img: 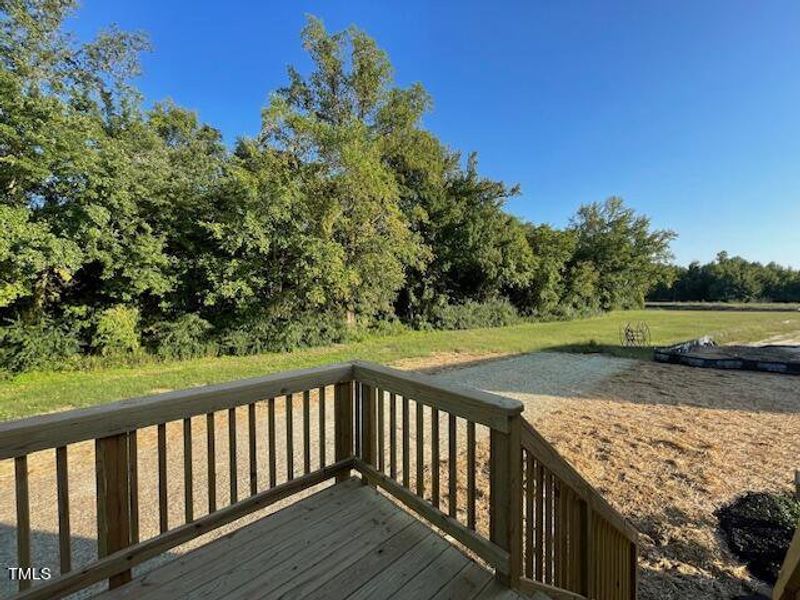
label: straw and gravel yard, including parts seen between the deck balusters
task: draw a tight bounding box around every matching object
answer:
[0,352,800,600]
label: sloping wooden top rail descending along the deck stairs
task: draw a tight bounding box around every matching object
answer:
[520,419,639,546]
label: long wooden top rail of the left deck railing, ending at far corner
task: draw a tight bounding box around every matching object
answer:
[0,363,353,460]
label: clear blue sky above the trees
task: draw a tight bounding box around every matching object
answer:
[68,0,800,267]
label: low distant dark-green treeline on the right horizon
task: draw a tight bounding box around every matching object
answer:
[648,252,800,302]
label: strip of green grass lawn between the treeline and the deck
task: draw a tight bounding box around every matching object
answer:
[0,310,800,420]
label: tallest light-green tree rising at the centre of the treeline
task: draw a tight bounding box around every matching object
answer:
[260,18,424,320]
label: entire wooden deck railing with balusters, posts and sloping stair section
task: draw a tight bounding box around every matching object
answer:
[0,361,636,600]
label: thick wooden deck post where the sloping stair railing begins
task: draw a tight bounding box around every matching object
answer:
[489,414,522,589]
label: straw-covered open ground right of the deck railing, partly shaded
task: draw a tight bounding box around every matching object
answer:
[440,353,800,600]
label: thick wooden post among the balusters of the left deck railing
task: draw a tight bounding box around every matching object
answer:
[95,433,132,589]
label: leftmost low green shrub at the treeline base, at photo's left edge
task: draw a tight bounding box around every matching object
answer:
[0,318,81,373]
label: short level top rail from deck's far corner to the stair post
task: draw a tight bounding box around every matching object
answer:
[353,360,525,433]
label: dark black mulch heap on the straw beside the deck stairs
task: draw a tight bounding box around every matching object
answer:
[716,492,800,585]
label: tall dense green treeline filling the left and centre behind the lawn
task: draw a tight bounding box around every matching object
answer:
[0,0,674,371]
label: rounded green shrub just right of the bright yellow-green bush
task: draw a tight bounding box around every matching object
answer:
[148,314,217,360]
